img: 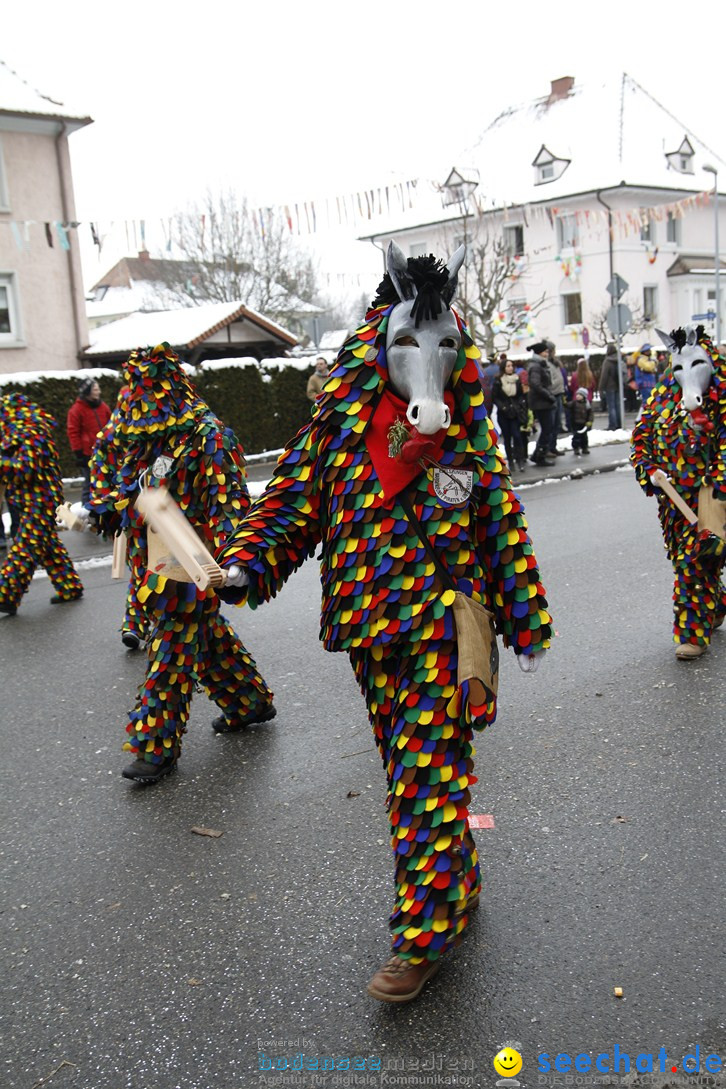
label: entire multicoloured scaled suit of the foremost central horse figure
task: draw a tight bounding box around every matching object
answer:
[219,305,551,963]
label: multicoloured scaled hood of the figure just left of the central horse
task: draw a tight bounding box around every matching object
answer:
[114,343,207,441]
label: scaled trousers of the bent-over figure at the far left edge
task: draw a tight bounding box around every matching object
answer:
[0,491,83,608]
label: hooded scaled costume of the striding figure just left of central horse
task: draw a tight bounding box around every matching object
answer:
[89,344,272,763]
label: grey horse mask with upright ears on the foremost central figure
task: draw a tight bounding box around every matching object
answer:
[385,242,466,435]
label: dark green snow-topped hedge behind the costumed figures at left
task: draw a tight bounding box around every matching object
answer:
[0,359,315,477]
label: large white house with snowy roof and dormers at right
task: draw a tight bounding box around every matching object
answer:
[366,74,726,355]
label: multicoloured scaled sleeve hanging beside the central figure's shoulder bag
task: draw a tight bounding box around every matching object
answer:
[477,425,552,654]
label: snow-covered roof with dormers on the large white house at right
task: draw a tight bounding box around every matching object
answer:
[366,73,726,237]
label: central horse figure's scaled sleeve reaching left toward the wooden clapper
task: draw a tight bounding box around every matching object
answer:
[217,426,322,609]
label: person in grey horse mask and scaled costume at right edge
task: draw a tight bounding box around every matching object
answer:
[630,326,726,661]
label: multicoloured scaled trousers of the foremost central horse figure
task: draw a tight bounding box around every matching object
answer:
[349,612,484,964]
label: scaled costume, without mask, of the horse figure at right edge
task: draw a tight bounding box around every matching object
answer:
[630,337,726,646]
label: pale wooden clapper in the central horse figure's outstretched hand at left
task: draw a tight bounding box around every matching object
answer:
[136,485,225,590]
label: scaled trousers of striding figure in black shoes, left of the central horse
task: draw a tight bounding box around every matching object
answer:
[124,574,272,763]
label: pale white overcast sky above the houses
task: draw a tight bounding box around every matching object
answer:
[0,0,726,289]
